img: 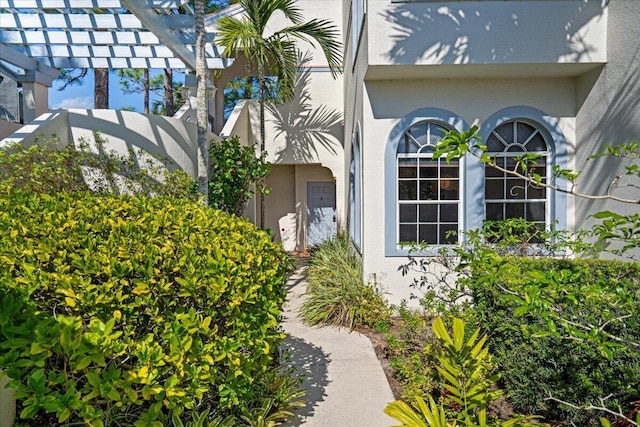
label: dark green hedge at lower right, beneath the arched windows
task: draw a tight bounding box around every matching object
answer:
[466,257,640,426]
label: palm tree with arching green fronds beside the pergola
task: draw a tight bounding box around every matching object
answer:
[218,0,342,227]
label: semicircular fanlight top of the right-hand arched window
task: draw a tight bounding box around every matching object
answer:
[487,120,549,154]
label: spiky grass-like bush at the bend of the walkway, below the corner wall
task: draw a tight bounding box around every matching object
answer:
[300,235,391,329]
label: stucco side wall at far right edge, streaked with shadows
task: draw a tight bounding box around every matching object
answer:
[576,0,640,249]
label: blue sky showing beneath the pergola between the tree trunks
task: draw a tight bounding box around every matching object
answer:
[49,70,184,113]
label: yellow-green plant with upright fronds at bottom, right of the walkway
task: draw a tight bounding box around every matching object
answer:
[385,317,546,427]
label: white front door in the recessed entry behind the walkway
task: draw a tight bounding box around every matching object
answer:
[307,182,336,246]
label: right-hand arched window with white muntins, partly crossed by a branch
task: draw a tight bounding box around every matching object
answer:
[484,119,551,228]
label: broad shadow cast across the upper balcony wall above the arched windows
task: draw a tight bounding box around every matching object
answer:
[380,1,603,64]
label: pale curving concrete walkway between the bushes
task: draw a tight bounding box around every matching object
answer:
[281,267,397,427]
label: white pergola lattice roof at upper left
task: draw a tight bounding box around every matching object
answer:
[0,0,239,70]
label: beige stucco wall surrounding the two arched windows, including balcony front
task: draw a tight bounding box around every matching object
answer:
[343,0,640,303]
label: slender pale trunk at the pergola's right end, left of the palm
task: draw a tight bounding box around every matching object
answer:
[195,0,209,206]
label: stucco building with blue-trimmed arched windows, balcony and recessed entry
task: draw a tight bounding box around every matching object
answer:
[219,0,640,303]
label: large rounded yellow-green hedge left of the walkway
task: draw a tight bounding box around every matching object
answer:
[0,192,287,426]
